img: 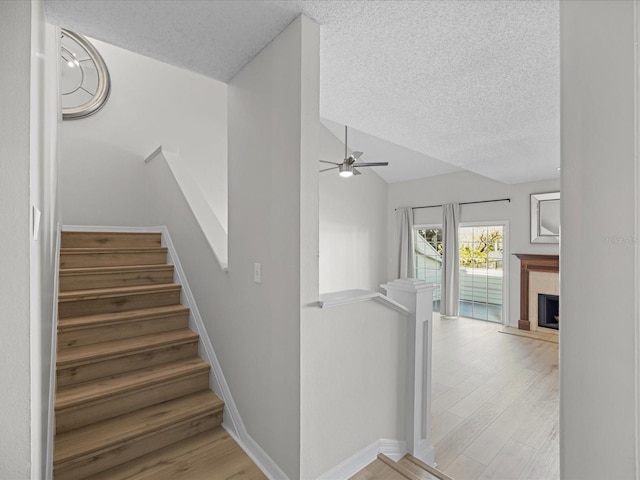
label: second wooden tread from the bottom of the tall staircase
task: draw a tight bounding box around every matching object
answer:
[55,357,210,411]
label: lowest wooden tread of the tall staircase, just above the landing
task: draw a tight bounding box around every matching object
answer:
[53,390,224,466]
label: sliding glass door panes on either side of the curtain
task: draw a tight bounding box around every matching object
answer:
[415,224,506,323]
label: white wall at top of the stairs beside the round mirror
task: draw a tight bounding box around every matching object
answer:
[60,40,227,229]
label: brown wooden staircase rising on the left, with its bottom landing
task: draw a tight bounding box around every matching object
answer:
[53,232,266,480]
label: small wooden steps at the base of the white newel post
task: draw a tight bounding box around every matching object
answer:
[350,453,452,480]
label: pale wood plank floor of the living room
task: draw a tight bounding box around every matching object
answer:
[432,314,560,480]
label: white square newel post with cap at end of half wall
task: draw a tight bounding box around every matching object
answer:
[381,278,436,465]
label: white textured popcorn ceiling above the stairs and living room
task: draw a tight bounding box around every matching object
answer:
[45,0,560,183]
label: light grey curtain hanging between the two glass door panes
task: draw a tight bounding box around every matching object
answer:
[440,203,460,317]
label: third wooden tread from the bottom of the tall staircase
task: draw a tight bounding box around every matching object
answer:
[56,328,199,368]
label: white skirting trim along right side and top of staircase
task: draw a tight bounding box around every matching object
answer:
[60,225,288,480]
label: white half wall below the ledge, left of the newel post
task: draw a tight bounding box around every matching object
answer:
[300,301,407,480]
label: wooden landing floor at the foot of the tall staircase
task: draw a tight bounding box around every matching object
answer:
[91,426,267,480]
